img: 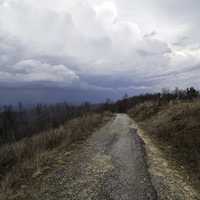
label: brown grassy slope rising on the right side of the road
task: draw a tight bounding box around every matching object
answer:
[129,100,200,190]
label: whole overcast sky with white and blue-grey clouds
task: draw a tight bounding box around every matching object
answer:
[0,0,200,103]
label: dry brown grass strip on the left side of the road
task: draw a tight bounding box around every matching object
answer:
[0,113,111,199]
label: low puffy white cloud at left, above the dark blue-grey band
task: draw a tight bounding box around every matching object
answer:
[0,60,79,86]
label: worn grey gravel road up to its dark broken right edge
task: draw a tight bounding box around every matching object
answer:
[29,114,157,200]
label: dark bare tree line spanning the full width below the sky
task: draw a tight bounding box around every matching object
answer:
[0,87,199,146]
